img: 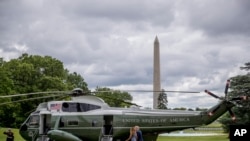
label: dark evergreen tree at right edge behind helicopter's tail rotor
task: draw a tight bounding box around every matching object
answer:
[219,63,250,132]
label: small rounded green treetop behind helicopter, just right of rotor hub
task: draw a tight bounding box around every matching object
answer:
[95,87,132,107]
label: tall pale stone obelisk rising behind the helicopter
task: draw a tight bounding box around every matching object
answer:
[153,36,161,109]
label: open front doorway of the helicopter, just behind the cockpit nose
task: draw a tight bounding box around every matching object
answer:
[39,111,51,135]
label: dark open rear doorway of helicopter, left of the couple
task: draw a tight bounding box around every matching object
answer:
[103,115,113,135]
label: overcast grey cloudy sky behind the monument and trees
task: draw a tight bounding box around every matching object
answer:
[0,0,250,108]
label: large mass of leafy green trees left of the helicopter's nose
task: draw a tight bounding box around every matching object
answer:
[0,54,88,127]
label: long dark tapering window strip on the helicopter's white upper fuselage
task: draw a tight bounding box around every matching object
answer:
[62,102,101,112]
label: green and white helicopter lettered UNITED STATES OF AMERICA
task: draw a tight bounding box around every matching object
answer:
[0,80,248,141]
